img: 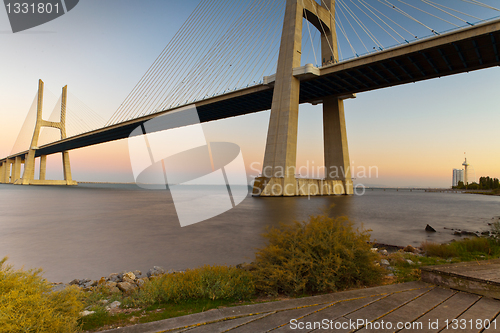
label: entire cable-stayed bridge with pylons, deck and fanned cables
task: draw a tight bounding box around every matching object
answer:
[0,0,500,196]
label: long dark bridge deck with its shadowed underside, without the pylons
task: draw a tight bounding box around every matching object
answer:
[4,20,500,158]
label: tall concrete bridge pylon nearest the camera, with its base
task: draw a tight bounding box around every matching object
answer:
[253,0,353,196]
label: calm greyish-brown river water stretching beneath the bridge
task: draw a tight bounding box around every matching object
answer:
[0,184,500,282]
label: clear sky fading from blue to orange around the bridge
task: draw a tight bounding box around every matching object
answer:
[0,0,500,187]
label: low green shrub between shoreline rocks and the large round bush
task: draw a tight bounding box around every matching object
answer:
[128,266,255,306]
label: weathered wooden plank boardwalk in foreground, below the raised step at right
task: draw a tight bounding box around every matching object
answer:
[99,281,500,333]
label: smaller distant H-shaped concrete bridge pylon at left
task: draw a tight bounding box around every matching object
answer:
[16,80,78,185]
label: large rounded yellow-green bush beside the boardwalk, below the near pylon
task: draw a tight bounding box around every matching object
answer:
[252,215,382,295]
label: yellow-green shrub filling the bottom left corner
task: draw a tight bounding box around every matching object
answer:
[0,258,83,333]
